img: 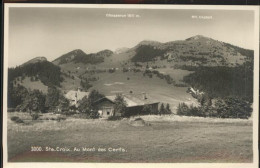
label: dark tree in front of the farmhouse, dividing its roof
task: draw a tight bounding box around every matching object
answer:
[113,94,127,116]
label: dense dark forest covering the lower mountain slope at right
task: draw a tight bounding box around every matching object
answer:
[183,62,253,103]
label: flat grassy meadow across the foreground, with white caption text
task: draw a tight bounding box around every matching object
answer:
[8,112,253,163]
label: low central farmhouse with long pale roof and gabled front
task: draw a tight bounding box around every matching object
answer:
[94,93,159,118]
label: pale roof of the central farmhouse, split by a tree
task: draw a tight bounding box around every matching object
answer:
[97,94,159,107]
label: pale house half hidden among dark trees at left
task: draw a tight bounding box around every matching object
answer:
[65,89,89,107]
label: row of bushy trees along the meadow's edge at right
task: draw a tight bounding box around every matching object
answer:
[177,97,252,118]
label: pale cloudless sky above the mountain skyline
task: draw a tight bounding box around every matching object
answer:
[8,7,254,67]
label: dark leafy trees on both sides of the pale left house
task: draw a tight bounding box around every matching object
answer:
[8,86,104,118]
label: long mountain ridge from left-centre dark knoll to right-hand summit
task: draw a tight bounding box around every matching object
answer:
[49,35,254,69]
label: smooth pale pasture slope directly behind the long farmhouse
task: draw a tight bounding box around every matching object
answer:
[93,72,197,111]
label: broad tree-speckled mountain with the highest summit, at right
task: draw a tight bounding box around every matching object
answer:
[131,35,253,66]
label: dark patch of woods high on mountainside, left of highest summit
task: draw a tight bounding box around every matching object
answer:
[131,45,165,62]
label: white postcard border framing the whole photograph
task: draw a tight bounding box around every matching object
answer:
[3,3,259,168]
